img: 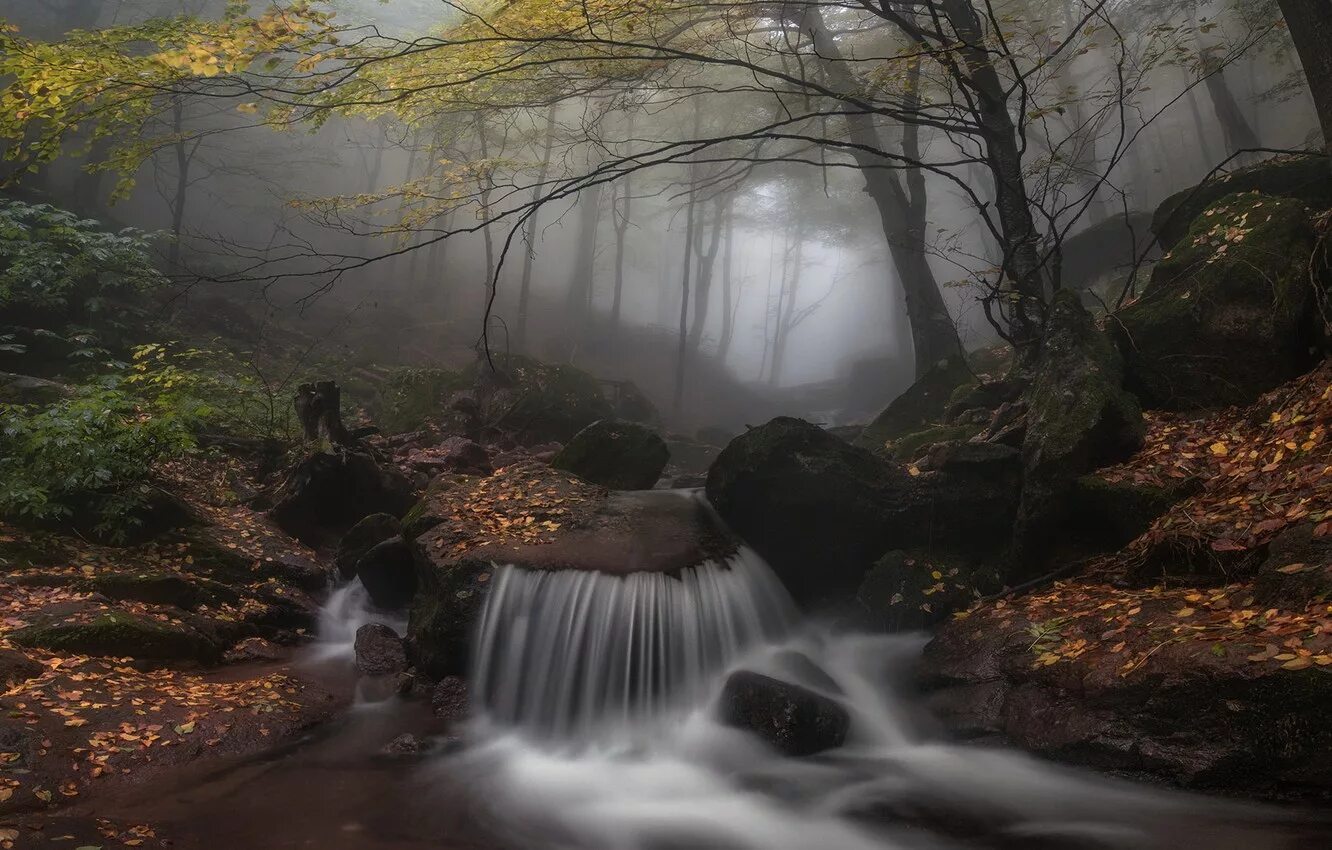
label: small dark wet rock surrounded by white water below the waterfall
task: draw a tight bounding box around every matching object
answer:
[719,670,851,758]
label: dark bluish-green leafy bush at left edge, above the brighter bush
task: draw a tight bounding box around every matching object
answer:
[0,201,164,370]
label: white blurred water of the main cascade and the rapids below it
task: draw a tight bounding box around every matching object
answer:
[437,554,1309,850]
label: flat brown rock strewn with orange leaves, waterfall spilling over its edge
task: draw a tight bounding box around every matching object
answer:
[408,462,738,678]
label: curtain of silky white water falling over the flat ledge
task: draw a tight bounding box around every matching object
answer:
[472,549,795,739]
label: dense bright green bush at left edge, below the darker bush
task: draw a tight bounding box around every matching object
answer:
[0,377,193,540]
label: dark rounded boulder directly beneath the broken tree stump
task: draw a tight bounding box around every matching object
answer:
[269,452,414,545]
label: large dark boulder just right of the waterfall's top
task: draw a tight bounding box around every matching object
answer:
[707,417,907,604]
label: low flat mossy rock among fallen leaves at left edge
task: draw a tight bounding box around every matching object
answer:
[8,612,221,663]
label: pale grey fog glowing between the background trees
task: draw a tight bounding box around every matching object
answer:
[0,0,1320,430]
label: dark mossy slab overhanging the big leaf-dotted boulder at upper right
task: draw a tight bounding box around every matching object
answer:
[1151,156,1332,249]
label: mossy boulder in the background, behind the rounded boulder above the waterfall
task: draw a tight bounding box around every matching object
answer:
[465,354,614,445]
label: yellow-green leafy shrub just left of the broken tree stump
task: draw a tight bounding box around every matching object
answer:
[125,342,296,442]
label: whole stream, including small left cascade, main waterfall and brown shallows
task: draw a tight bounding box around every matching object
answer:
[80,553,1327,850]
